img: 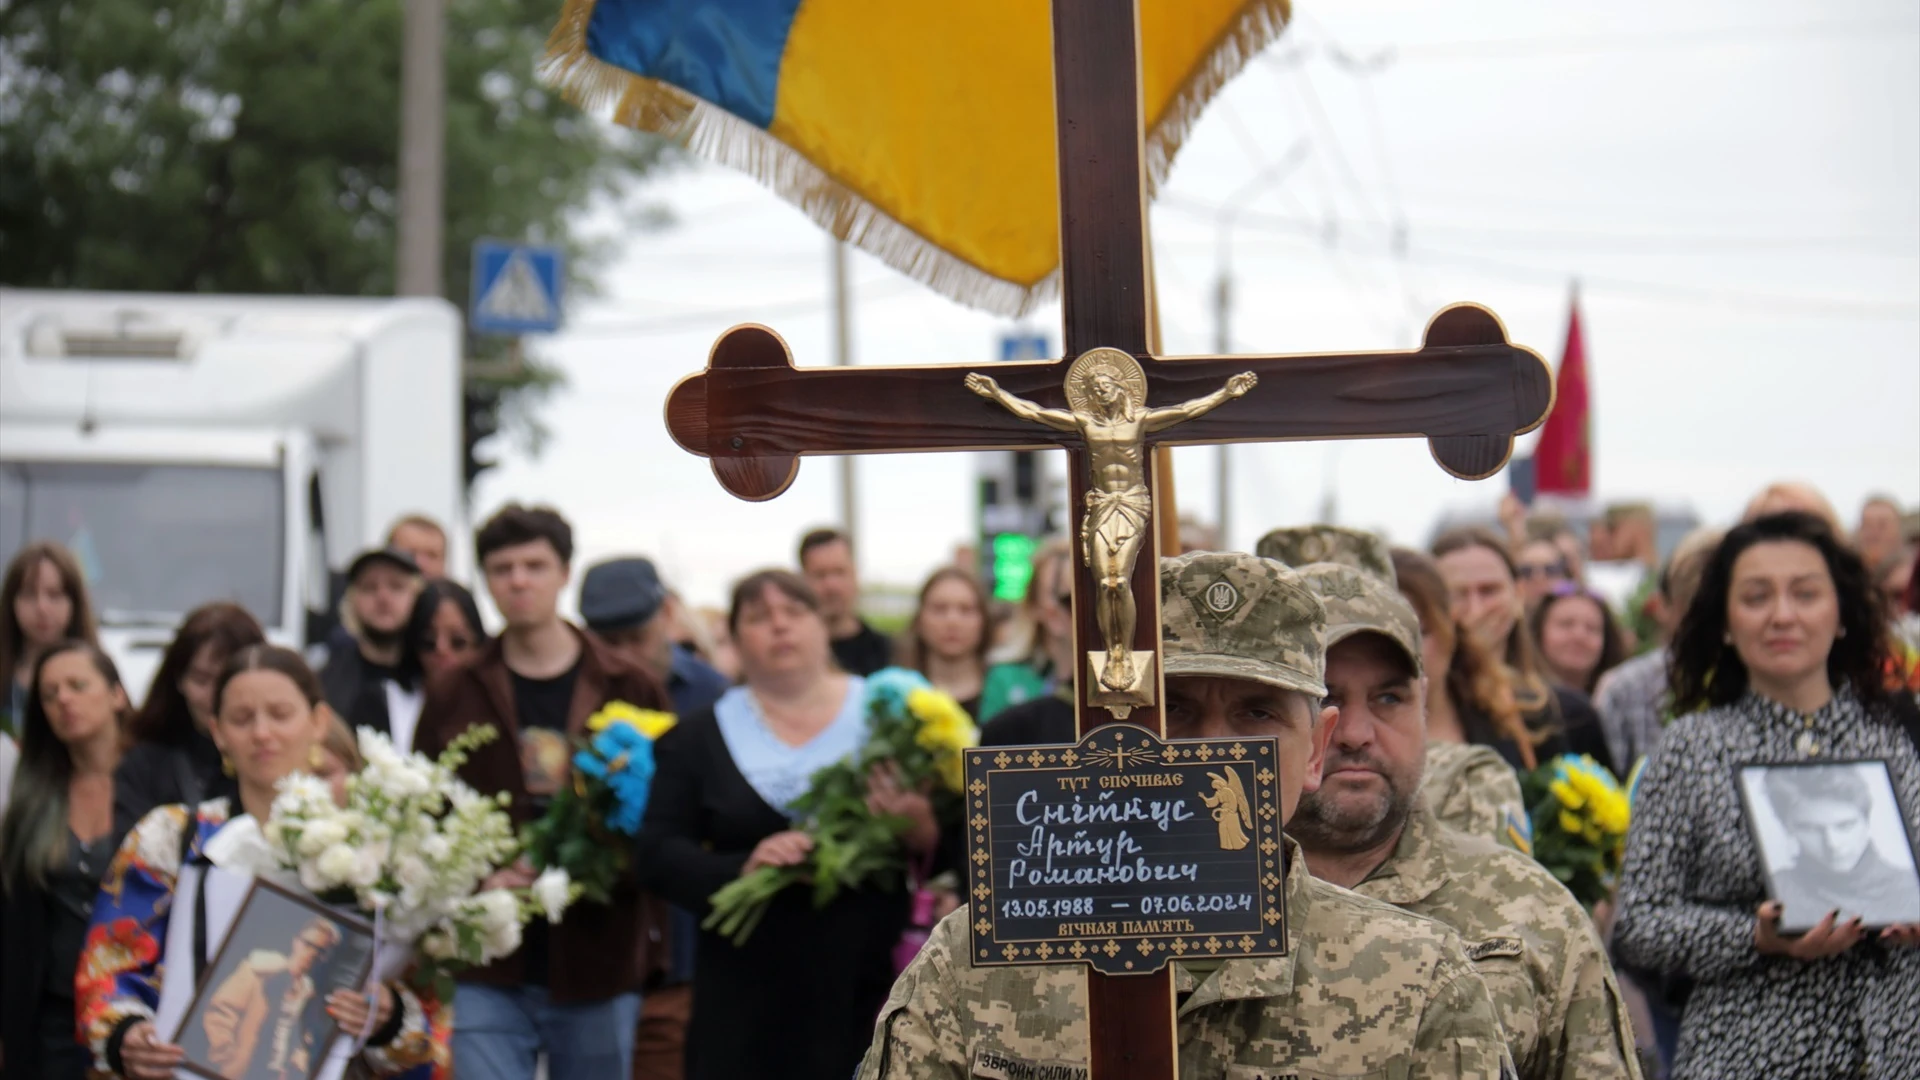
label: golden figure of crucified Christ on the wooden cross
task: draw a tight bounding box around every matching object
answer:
[966,348,1258,717]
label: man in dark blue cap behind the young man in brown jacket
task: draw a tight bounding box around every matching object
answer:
[580,557,728,1080]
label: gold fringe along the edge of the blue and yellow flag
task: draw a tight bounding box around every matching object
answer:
[540,0,1290,317]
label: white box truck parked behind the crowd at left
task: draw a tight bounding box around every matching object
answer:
[0,288,467,700]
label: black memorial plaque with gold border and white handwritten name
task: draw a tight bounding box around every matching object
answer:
[966,724,1286,974]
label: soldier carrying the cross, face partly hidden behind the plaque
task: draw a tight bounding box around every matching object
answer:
[858,552,1513,1080]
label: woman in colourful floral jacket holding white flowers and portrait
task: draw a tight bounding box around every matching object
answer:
[75,646,445,1080]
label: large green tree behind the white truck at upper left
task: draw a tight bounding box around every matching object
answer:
[0,0,664,482]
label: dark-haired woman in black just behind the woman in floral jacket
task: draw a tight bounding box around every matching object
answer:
[113,601,267,834]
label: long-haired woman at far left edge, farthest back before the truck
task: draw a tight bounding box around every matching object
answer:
[0,540,100,732]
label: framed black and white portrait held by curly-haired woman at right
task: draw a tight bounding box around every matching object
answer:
[1740,759,1920,934]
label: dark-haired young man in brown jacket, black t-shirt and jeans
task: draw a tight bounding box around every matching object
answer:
[417,505,672,1080]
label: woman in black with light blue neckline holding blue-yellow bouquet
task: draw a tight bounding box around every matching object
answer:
[637,571,939,1080]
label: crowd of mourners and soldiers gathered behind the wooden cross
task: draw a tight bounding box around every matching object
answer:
[0,484,1920,1080]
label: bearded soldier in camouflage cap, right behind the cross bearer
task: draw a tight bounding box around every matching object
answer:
[1288,563,1640,1080]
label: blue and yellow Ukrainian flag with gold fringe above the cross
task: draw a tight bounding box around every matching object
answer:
[545,0,1288,313]
